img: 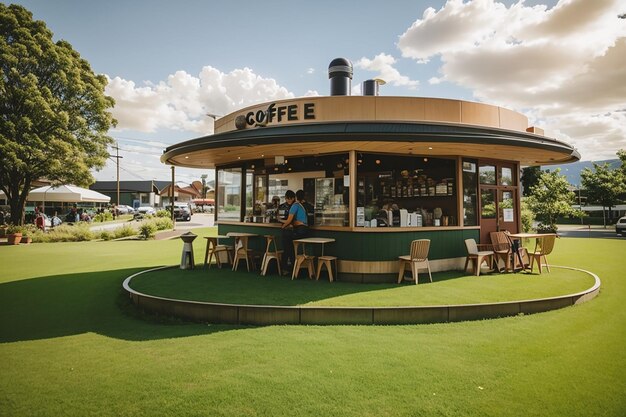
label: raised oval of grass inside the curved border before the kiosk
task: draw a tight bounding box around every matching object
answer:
[131,264,594,307]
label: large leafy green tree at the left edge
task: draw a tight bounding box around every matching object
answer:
[0,3,116,224]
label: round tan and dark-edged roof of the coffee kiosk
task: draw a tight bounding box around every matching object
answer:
[161,96,580,168]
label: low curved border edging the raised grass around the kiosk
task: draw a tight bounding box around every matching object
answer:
[122,265,600,326]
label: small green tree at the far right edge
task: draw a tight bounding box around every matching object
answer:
[580,160,626,227]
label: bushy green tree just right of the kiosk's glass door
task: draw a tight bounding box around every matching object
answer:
[526,169,582,233]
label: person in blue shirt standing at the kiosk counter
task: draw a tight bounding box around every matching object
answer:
[280,190,309,275]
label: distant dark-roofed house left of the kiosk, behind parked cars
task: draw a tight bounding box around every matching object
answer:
[89,180,171,207]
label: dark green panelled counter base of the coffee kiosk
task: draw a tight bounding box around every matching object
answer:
[218,224,480,261]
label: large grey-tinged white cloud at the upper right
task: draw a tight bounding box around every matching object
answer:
[398,0,626,159]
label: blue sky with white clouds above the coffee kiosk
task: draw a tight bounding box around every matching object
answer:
[13,0,626,182]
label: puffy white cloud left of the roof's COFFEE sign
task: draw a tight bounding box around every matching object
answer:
[106,66,293,134]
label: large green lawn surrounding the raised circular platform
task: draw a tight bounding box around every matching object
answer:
[0,228,626,417]
